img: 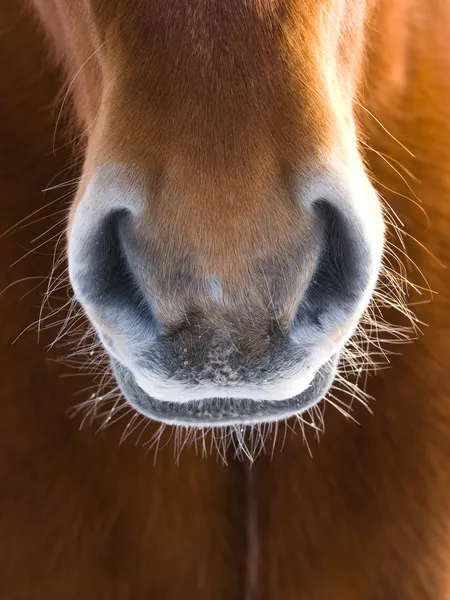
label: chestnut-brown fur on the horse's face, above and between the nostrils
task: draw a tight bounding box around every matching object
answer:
[35,0,371,322]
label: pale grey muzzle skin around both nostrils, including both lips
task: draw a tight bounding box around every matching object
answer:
[69,161,384,427]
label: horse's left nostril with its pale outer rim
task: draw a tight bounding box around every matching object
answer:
[69,209,154,332]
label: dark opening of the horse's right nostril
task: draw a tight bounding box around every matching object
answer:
[296,200,370,329]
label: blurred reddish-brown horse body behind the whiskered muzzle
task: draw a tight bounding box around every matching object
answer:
[0,0,450,600]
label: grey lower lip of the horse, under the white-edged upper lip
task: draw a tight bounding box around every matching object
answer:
[111,356,338,427]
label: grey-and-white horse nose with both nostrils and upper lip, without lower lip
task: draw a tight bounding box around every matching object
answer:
[69,164,381,426]
